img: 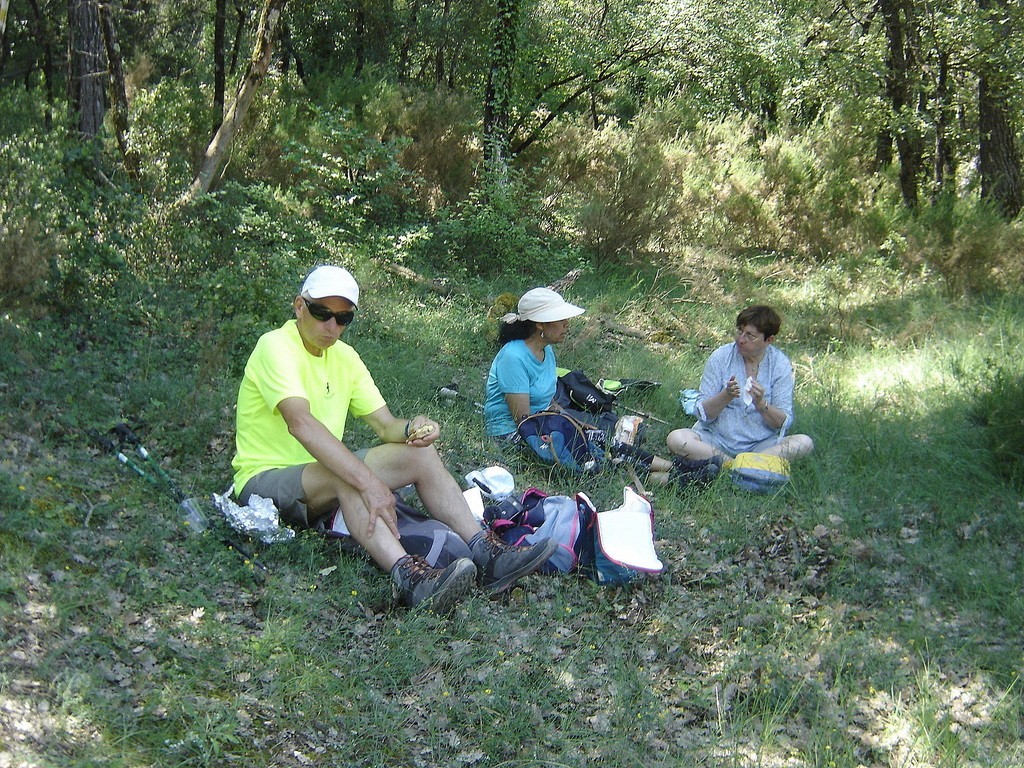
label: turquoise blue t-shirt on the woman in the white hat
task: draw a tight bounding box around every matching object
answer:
[483,340,558,435]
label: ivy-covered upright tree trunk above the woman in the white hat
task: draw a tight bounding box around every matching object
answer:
[483,0,519,178]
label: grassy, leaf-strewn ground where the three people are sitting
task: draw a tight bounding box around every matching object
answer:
[0,249,1024,767]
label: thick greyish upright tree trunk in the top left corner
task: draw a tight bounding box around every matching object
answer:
[68,0,106,138]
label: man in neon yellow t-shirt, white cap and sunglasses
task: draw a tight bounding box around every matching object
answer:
[231,266,557,611]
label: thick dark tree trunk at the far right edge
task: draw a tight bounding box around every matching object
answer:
[978,0,1024,219]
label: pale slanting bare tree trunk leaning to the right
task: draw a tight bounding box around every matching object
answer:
[178,0,287,204]
